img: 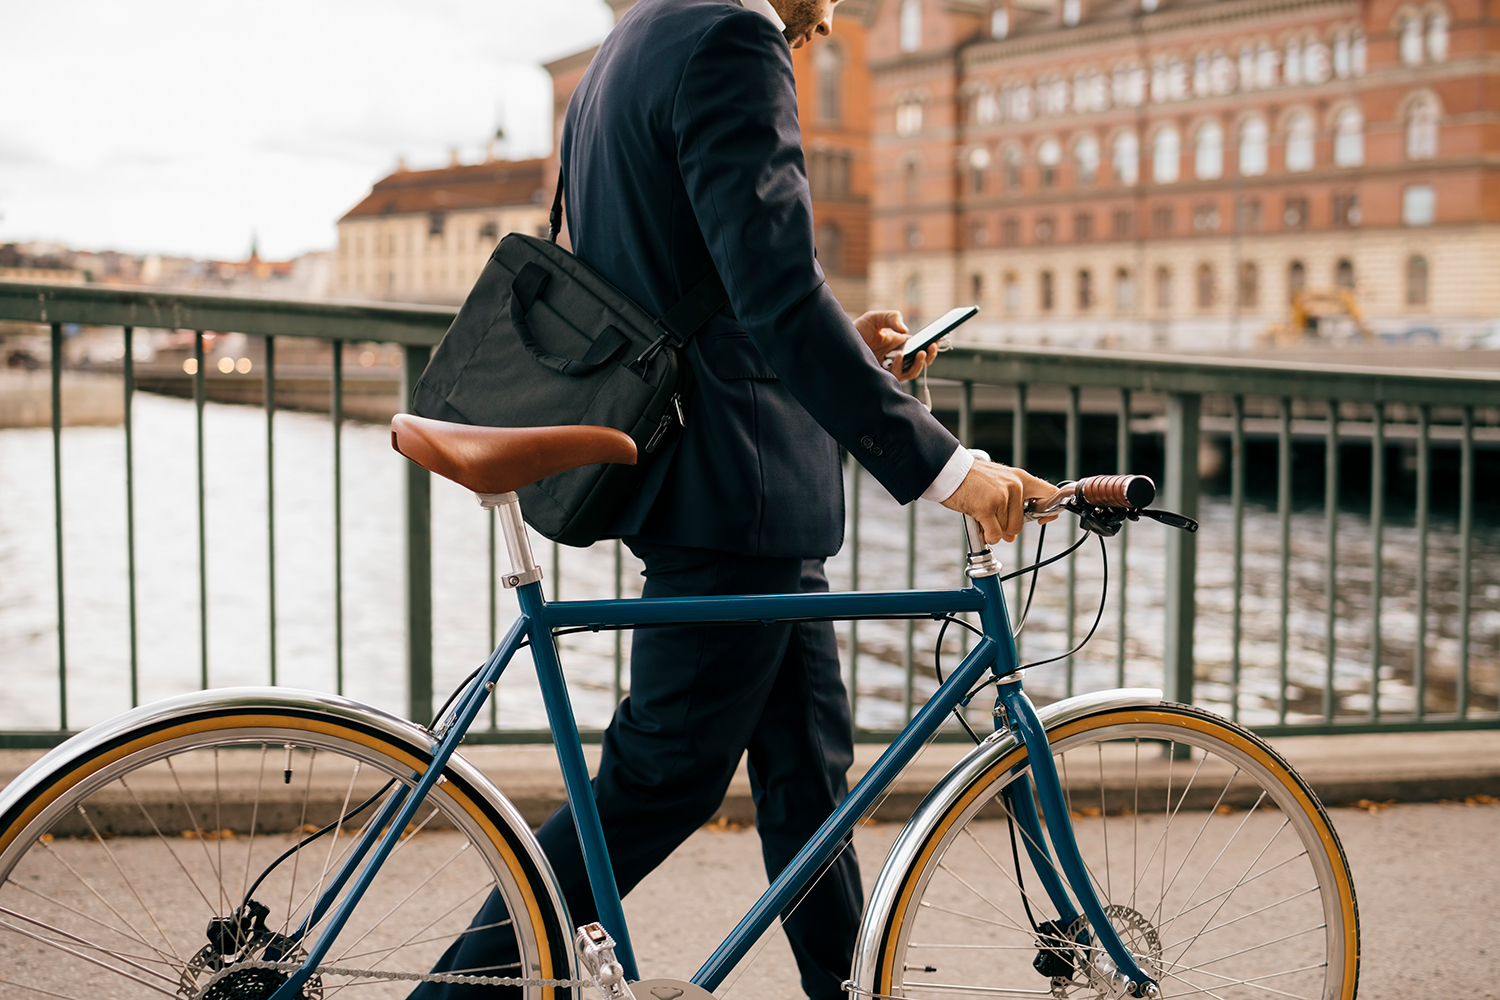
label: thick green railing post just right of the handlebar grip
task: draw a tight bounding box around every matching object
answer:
[1161,393,1203,705]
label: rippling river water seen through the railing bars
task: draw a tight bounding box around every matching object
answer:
[0,394,1500,729]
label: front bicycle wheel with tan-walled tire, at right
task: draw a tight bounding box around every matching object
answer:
[858,705,1359,1000]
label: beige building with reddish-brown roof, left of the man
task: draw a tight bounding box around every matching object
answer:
[333,157,552,303]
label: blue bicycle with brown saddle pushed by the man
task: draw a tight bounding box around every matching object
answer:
[0,415,1359,1000]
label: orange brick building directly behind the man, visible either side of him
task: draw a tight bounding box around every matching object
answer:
[543,0,881,313]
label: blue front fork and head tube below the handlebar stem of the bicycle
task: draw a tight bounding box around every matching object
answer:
[965,516,1161,1000]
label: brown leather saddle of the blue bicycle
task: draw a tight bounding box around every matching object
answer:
[390,414,636,493]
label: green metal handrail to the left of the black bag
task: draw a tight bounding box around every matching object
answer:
[0,280,458,346]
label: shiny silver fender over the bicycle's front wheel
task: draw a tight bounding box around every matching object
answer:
[851,688,1161,991]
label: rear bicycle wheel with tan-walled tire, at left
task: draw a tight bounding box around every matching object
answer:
[0,706,572,1000]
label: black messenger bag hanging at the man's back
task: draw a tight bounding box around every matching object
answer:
[411,188,729,546]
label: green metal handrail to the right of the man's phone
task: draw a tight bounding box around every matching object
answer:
[932,346,1500,406]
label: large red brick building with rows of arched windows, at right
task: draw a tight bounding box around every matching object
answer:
[867,0,1500,348]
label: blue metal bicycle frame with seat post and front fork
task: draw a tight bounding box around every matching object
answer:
[272,495,1155,1000]
